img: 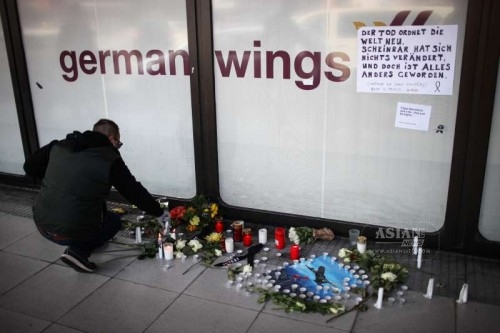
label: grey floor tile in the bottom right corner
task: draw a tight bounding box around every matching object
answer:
[457,302,500,333]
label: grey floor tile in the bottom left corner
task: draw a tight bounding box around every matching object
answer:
[0,308,50,333]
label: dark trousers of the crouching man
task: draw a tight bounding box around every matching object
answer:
[38,211,122,258]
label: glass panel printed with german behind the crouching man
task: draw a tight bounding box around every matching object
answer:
[18,0,196,198]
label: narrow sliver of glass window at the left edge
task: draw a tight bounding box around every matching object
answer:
[0,13,24,175]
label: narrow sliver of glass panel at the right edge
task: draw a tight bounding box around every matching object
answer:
[479,65,500,242]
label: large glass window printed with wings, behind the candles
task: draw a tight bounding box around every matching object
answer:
[213,0,467,231]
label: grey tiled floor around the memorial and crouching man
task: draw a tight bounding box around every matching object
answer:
[0,185,500,333]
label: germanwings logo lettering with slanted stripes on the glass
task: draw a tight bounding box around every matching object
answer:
[59,10,432,90]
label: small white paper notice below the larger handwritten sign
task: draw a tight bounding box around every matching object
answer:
[394,102,431,131]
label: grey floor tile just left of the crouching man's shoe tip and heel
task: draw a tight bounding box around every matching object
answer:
[4,231,66,262]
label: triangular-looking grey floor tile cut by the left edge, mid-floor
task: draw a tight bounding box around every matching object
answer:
[0,251,49,295]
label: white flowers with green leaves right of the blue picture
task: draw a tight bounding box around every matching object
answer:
[338,248,408,291]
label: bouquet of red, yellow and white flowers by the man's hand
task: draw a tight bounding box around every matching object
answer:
[170,195,219,232]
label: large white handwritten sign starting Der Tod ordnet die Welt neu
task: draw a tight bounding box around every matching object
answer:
[357,25,457,95]
